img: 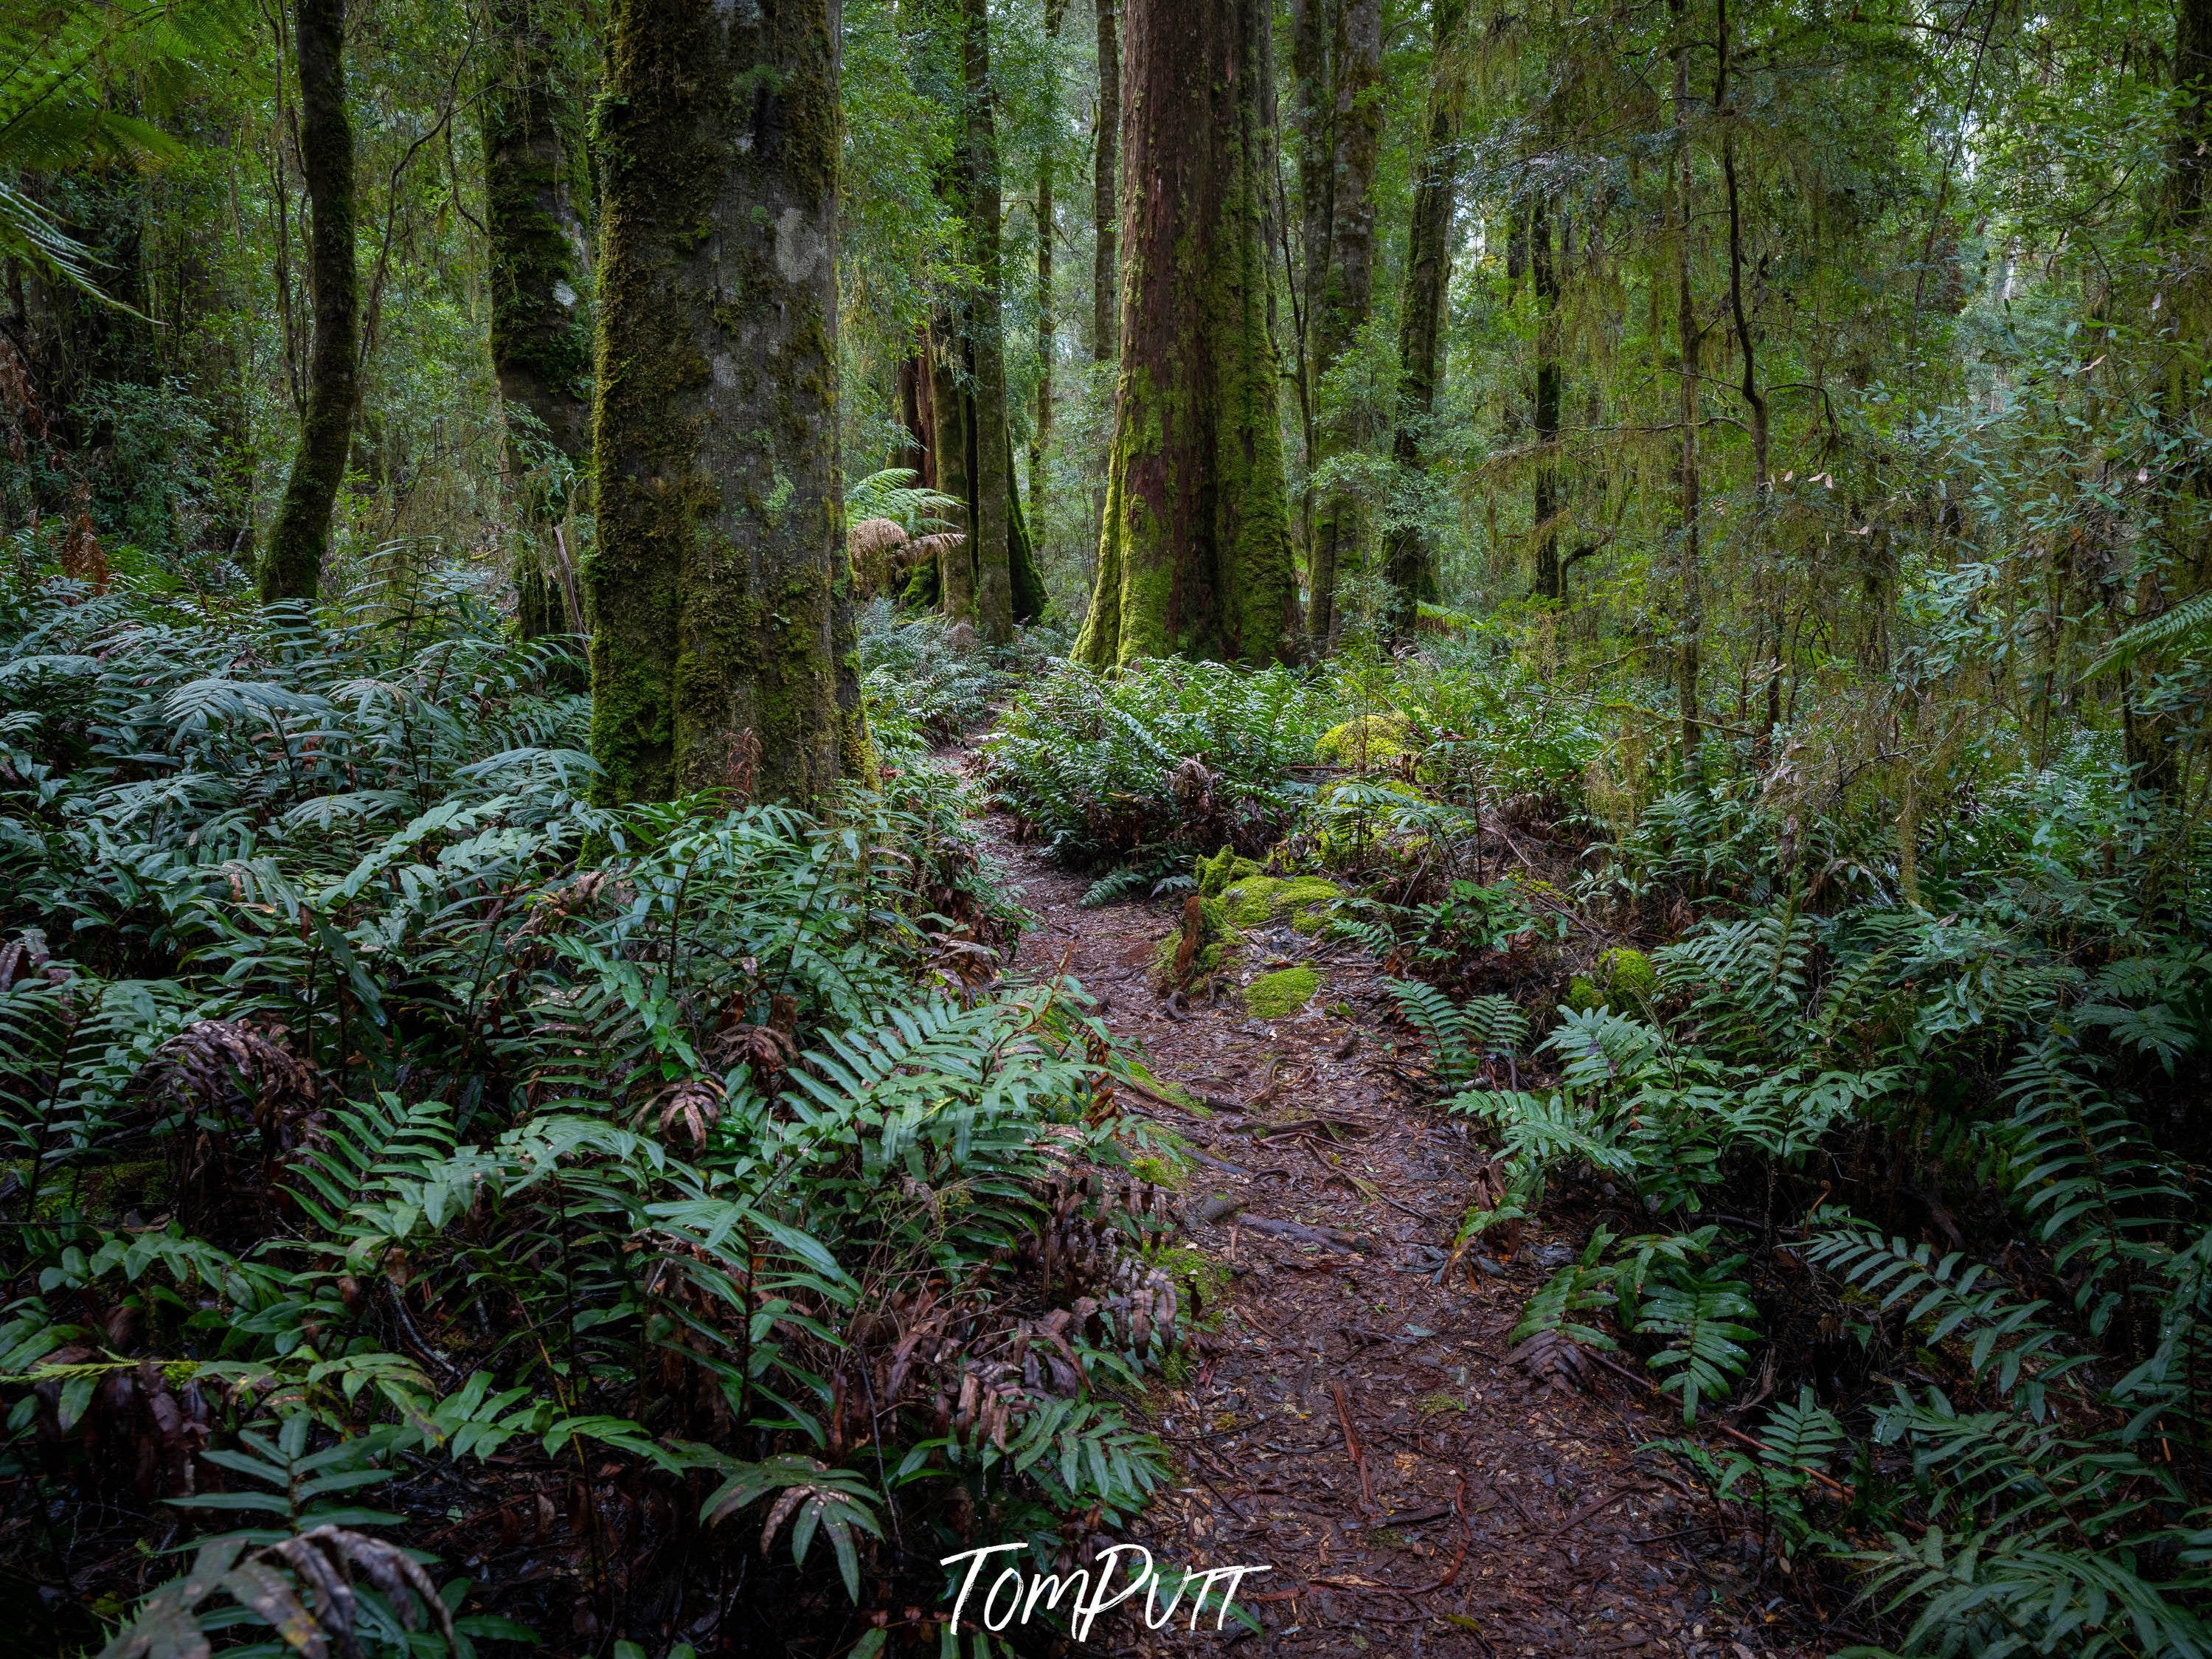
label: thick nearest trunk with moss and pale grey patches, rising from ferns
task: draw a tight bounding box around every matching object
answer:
[589,0,867,803]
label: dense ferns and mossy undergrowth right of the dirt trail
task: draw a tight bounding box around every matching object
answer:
[987,642,2212,1655]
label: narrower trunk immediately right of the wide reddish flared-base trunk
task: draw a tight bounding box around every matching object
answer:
[1305,0,1382,651]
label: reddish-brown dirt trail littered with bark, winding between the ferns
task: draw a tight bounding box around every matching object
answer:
[987,821,1827,1659]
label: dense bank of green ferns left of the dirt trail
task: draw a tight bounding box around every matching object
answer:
[0,564,1179,1655]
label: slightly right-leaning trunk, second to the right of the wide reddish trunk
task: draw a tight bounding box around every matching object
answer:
[1384,0,1466,642]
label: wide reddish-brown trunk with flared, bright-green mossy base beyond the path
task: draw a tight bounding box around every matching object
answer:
[1075,0,1296,668]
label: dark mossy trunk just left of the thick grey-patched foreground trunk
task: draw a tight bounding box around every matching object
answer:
[485,0,591,637]
